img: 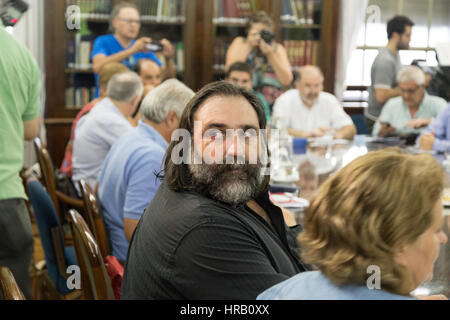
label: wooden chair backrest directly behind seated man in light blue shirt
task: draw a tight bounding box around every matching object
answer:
[79,179,111,259]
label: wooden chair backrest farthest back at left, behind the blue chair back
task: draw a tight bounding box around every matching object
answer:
[34,138,64,223]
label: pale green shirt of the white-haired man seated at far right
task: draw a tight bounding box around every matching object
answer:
[372,92,447,137]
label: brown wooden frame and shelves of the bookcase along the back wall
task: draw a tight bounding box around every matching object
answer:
[44,0,339,167]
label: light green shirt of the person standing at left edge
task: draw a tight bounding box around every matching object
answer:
[0,24,41,200]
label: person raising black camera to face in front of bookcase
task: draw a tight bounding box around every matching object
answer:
[225,11,293,111]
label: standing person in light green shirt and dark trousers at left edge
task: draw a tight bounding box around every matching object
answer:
[0,21,41,299]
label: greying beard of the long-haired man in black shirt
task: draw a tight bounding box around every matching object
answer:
[189,159,264,207]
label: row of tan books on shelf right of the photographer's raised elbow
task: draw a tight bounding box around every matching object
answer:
[283,40,320,69]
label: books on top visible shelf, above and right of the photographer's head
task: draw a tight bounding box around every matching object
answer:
[281,0,322,24]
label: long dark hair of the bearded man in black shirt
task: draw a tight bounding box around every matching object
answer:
[158,81,270,193]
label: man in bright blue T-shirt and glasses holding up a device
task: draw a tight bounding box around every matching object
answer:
[91,2,175,96]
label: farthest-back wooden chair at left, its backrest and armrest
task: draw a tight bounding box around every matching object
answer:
[34,138,83,232]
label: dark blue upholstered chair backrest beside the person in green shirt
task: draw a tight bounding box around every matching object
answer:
[27,179,72,294]
